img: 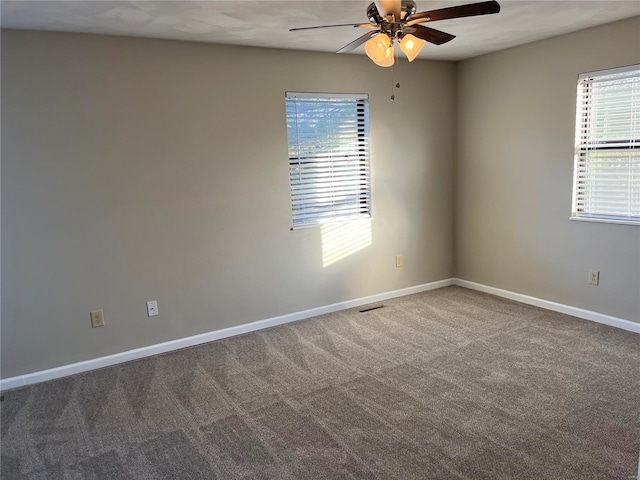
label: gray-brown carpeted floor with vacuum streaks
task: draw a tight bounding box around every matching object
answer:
[0,287,640,480]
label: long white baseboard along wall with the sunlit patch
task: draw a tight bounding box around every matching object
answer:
[0,278,455,391]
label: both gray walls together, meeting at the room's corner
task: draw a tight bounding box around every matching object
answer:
[0,18,640,378]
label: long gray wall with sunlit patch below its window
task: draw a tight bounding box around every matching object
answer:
[1,31,455,378]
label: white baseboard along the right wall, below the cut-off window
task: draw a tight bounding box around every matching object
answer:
[454,278,640,333]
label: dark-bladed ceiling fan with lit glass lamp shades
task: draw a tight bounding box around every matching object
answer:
[289,0,500,67]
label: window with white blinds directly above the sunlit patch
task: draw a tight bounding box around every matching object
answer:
[286,92,371,229]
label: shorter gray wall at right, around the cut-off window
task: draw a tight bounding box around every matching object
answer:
[455,17,640,322]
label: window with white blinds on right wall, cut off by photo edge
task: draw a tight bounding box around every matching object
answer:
[571,65,640,225]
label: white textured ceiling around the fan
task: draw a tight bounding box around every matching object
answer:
[0,0,640,60]
